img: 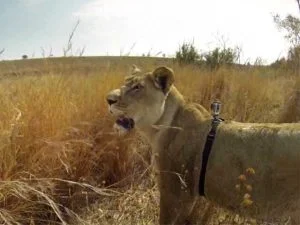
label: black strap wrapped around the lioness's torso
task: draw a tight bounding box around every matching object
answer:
[199,117,224,196]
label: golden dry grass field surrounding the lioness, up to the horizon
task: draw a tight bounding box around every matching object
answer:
[0,57,300,225]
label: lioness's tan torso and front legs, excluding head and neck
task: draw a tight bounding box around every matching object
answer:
[150,89,300,224]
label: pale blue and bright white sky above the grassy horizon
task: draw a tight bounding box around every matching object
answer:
[0,0,300,63]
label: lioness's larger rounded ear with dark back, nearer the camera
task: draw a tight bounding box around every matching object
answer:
[152,66,175,94]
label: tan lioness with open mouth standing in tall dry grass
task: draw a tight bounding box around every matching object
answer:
[107,67,300,225]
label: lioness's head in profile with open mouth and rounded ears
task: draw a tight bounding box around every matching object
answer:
[106,66,174,133]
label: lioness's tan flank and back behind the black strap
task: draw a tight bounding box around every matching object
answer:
[206,122,300,221]
